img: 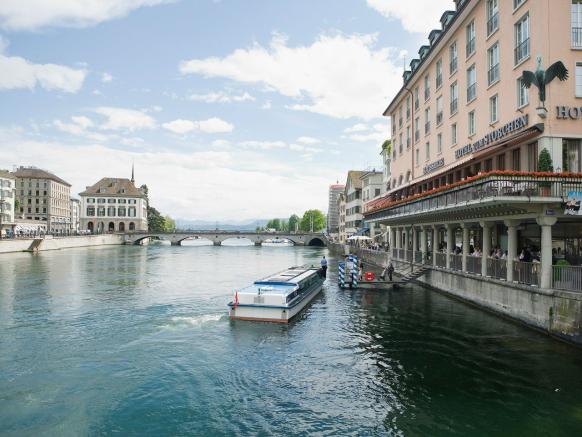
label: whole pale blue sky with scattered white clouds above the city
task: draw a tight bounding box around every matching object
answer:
[0,0,454,221]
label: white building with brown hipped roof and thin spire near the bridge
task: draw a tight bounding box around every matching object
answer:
[79,178,148,233]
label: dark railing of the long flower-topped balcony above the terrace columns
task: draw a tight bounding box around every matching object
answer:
[367,172,582,219]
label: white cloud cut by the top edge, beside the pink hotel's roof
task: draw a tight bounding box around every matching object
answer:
[367,0,455,33]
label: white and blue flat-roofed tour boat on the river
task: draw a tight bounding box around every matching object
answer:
[228,267,324,323]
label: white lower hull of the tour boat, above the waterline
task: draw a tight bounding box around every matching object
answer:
[228,283,323,323]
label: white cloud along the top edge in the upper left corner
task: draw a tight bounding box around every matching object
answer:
[0,0,168,30]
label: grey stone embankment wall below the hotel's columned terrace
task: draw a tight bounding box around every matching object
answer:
[344,248,582,346]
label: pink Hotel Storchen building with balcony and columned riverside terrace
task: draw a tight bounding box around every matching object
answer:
[364,0,582,291]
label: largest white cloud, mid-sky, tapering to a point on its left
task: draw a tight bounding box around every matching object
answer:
[180,34,402,119]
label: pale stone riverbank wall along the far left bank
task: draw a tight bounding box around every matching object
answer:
[0,235,124,254]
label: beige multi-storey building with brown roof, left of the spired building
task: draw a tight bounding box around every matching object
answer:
[14,167,71,234]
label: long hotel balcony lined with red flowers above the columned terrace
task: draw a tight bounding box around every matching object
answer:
[366,171,582,221]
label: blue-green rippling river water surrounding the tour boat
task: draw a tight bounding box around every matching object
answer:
[0,246,582,436]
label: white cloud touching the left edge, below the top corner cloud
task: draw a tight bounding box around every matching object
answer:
[0,37,87,93]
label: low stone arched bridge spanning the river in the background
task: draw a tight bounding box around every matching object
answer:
[124,231,327,246]
